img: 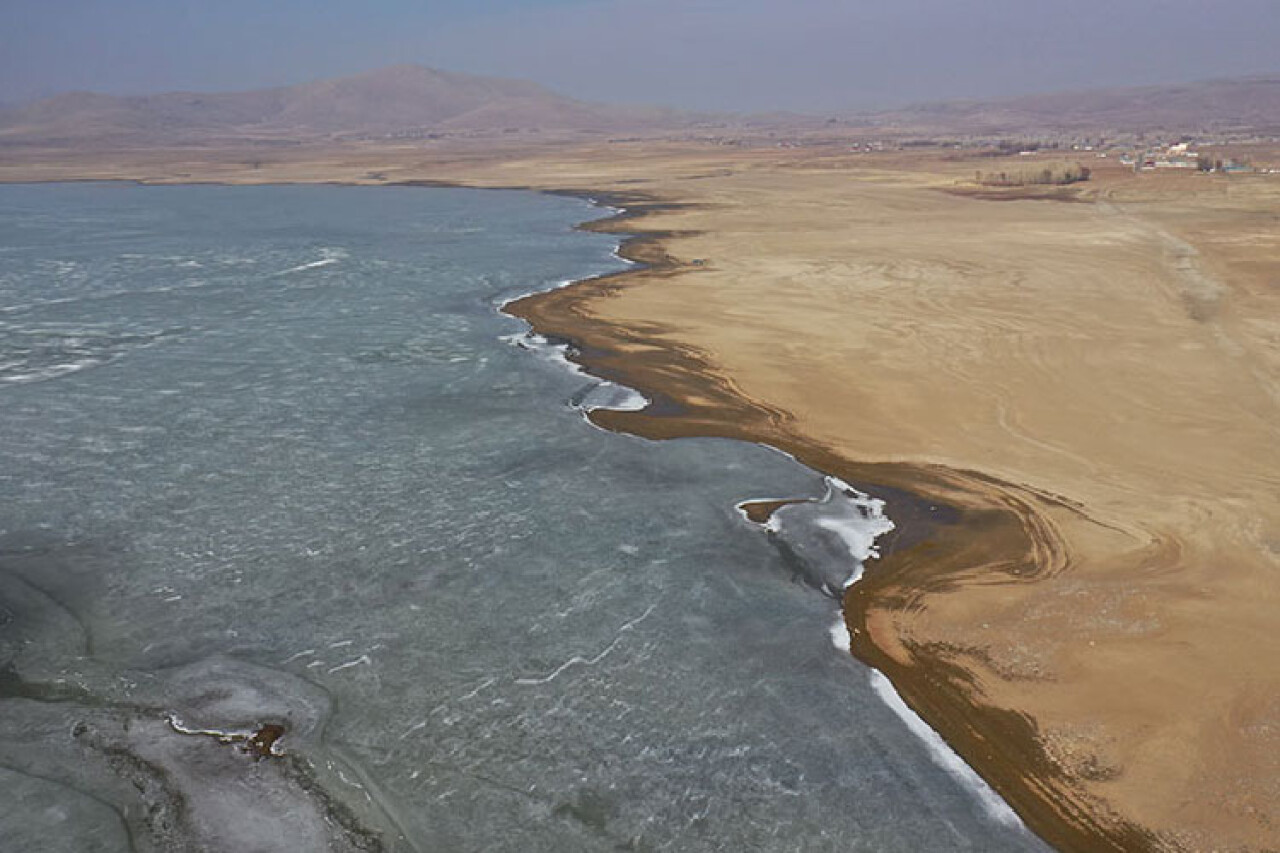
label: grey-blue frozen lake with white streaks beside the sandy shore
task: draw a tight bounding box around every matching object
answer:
[0,184,1044,850]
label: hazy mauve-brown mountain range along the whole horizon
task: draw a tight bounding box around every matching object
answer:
[0,65,1280,146]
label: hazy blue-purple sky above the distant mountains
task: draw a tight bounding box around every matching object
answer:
[0,0,1280,110]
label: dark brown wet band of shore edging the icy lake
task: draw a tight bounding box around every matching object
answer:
[502,191,1158,850]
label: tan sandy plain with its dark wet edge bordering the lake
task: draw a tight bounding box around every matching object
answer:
[0,142,1280,849]
